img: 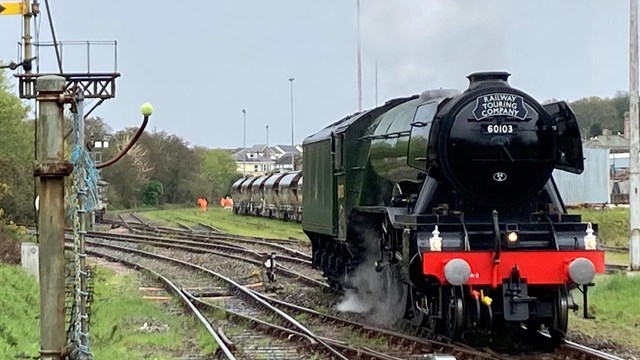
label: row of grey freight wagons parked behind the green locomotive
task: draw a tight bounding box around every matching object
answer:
[231,171,302,222]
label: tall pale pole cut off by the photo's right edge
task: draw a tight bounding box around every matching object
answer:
[629,0,640,270]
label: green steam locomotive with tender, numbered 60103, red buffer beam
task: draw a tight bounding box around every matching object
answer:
[302,72,605,340]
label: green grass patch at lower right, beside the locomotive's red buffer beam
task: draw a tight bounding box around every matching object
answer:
[569,274,640,349]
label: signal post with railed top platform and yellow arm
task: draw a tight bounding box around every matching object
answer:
[0,0,120,360]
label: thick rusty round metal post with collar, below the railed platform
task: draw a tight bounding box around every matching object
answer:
[34,75,72,360]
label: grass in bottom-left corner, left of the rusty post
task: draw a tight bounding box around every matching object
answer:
[0,263,40,359]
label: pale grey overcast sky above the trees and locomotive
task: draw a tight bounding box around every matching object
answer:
[0,0,629,148]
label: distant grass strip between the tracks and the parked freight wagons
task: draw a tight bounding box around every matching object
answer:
[142,207,307,240]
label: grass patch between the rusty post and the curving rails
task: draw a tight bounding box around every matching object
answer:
[89,267,216,360]
